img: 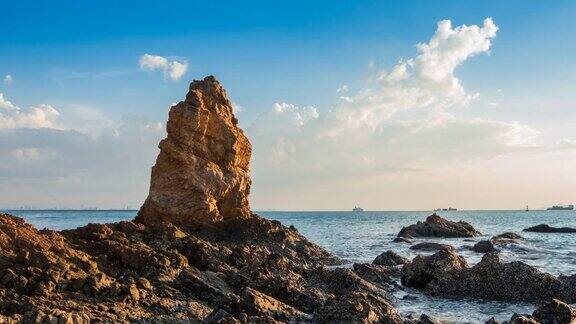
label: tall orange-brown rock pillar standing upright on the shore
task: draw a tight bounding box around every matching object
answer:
[136,76,252,224]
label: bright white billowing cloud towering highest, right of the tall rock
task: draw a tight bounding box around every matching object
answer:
[333,18,498,132]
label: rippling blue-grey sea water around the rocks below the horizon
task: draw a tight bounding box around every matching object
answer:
[8,210,576,323]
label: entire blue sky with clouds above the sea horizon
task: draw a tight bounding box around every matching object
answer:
[0,0,576,210]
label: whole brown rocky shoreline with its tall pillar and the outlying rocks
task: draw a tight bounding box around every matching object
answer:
[0,77,576,324]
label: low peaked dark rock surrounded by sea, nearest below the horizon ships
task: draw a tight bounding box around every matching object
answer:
[397,214,480,238]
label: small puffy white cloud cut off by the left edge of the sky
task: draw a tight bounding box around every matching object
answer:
[0,93,60,130]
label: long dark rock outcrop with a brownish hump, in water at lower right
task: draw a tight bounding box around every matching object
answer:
[402,250,576,303]
